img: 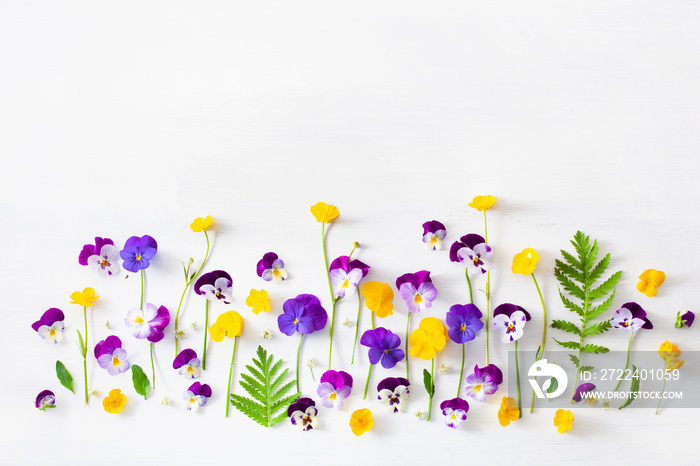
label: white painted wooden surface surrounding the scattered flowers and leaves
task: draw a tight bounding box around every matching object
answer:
[0,1,700,464]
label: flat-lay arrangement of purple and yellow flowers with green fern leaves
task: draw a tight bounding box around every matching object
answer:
[28,202,695,436]
